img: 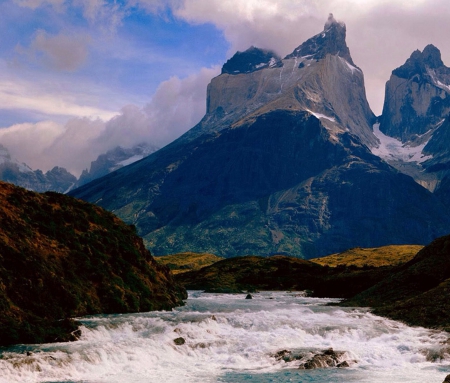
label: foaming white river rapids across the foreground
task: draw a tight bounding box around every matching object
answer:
[0,292,450,383]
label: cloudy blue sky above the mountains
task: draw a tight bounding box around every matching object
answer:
[0,0,450,176]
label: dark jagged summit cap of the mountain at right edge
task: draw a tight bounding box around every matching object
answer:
[392,44,445,78]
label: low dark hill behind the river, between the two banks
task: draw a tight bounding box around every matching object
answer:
[175,255,394,298]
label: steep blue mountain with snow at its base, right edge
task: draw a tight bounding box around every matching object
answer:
[374,45,450,194]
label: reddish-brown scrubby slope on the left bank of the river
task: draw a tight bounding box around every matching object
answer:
[0,182,186,345]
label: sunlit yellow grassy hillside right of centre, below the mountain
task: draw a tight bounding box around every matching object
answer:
[310,245,423,267]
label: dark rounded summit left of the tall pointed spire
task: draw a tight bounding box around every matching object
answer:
[222,46,283,74]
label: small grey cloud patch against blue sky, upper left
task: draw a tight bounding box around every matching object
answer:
[27,30,91,72]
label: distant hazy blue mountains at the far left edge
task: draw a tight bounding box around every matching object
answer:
[0,145,77,193]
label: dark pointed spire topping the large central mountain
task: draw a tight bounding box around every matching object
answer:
[285,13,355,66]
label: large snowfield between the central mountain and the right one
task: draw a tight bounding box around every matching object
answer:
[371,124,433,164]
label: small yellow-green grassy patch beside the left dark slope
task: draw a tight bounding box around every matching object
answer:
[155,252,223,274]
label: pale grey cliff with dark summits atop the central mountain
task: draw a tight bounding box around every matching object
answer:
[183,18,376,146]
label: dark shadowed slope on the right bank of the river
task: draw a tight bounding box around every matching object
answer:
[345,235,450,331]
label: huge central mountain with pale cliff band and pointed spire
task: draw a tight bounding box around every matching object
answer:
[71,15,450,258]
